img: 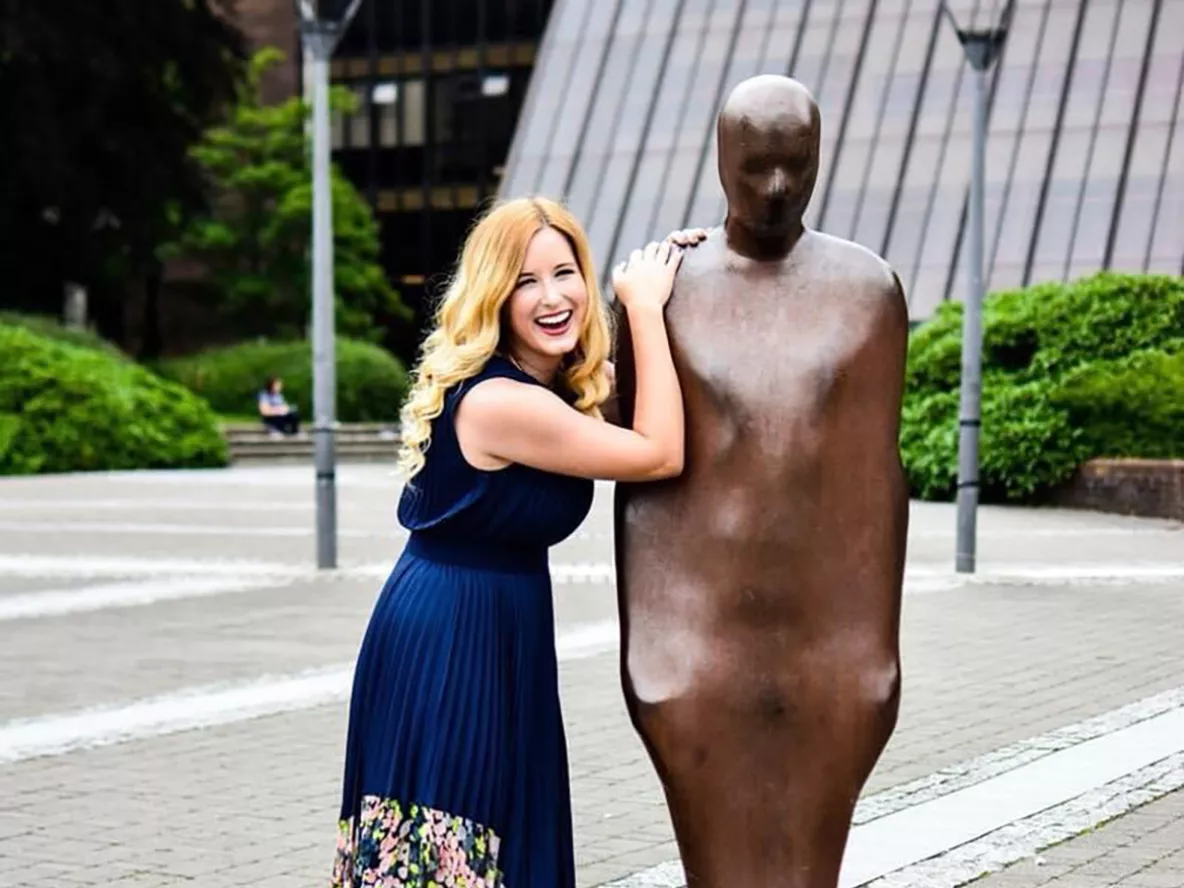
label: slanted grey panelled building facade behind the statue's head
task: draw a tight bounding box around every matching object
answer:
[497,0,1184,317]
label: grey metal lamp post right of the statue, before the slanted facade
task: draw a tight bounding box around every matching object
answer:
[941,0,1015,573]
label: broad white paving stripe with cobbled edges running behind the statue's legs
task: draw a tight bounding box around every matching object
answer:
[606,688,1184,888]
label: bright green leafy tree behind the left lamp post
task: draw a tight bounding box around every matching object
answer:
[164,49,412,340]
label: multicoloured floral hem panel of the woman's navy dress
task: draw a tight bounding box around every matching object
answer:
[333,796,504,888]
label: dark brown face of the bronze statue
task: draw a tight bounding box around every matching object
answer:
[720,118,818,237]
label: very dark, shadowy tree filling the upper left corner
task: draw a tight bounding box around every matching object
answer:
[0,0,246,339]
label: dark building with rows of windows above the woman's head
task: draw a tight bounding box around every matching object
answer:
[330,0,552,353]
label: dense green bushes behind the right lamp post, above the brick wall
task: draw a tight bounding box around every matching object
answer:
[901,272,1184,501]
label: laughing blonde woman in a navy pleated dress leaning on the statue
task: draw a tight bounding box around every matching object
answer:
[334,199,695,888]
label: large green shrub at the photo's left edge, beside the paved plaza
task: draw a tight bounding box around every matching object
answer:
[0,324,227,475]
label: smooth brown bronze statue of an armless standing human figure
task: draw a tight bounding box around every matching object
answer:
[616,76,908,888]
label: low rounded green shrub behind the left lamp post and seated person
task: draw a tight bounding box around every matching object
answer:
[157,339,408,423]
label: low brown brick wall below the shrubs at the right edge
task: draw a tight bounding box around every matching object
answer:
[1054,459,1184,521]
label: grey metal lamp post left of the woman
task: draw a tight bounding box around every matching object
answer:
[296,0,361,570]
